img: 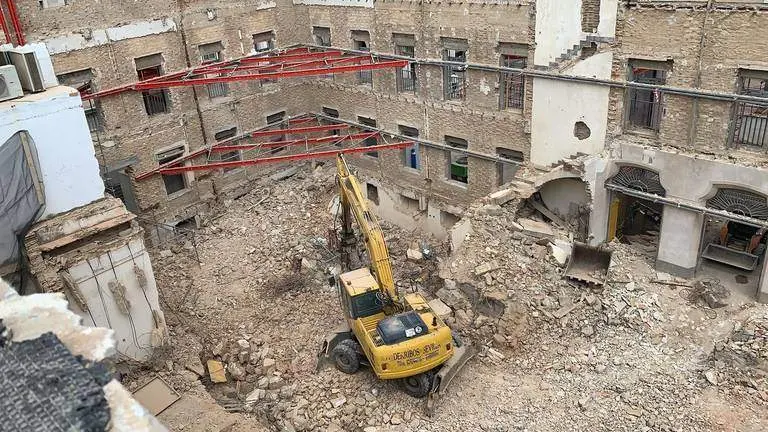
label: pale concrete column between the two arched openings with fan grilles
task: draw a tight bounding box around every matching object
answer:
[656,206,704,277]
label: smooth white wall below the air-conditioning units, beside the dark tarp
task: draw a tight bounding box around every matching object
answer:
[0,86,104,218]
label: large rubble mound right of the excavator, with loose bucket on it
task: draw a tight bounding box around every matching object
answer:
[435,202,664,347]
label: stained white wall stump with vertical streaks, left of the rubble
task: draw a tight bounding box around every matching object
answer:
[68,235,162,360]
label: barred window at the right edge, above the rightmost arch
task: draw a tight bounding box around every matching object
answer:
[731,69,768,149]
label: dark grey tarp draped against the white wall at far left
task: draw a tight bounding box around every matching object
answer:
[0,131,44,266]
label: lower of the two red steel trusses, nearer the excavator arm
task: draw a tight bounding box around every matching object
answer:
[136,114,414,180]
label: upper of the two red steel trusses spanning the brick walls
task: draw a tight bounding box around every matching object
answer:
[82,47,408,100]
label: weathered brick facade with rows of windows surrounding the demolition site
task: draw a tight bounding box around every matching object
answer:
[10,0,768,236]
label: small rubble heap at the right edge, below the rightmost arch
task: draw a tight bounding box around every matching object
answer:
[704,315,768,402]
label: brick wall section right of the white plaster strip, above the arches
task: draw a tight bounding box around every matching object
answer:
[609,7,768,159]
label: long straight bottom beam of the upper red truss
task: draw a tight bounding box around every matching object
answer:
[134,60,409,90]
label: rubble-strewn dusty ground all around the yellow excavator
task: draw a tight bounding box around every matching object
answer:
[126,166,768,432]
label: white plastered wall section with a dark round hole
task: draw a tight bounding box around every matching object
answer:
[531,52,613,168]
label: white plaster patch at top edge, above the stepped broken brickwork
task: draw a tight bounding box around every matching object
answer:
[533,0,582,66]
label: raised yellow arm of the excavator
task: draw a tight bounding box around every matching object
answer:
[336,154,400,304]
